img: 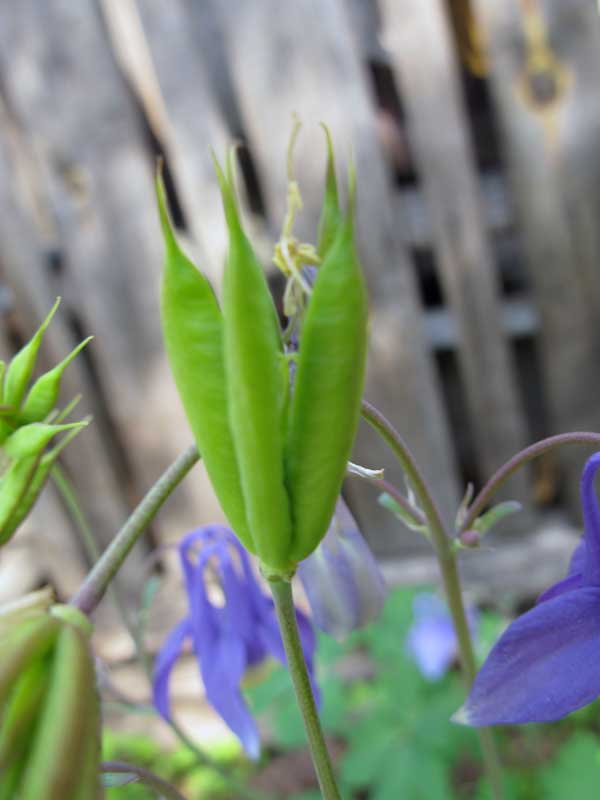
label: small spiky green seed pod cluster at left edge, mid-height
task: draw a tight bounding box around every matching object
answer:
[0,300,91,545]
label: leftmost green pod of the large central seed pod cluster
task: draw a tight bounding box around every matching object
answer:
[156,170,255,552]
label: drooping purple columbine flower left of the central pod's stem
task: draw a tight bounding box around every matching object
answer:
[153,525,318,758]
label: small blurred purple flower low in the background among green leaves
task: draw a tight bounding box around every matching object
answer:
[406,593,477,681]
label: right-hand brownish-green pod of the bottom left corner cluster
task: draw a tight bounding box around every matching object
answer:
[20,608,100,800]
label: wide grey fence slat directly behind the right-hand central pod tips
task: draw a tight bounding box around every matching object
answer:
[210,0,457,551]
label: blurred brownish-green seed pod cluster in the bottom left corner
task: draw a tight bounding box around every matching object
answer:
[0,606,103,800]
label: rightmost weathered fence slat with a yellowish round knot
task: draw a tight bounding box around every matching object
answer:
[476,0,600,509]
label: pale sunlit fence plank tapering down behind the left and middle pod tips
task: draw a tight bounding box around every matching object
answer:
[102,0,232,286]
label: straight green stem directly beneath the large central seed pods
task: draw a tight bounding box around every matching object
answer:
[269,578,341,800]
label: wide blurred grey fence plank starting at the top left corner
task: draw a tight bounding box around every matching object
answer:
[0,0,203,544]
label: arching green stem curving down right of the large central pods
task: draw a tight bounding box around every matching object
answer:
[362,401,504,800]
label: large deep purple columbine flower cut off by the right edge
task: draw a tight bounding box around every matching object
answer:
[454,453,600,727]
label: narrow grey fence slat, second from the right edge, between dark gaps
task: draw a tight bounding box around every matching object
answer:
[383,0,526,500]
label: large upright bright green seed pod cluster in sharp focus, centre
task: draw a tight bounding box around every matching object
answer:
[157,138,367,574]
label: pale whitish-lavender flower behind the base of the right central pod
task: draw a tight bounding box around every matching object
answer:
[298,498,387,639]
